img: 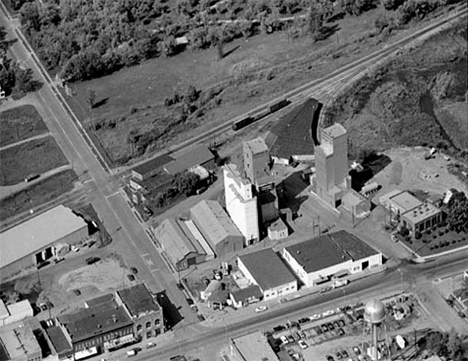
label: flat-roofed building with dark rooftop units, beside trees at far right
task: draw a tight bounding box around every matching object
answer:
[401,203,442,234]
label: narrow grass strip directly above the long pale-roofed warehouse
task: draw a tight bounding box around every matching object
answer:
[0,170,77,221]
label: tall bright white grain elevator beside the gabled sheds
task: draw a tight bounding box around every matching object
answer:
[223,164,260,246]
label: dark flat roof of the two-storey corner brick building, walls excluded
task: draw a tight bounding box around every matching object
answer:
[117,283,160,317]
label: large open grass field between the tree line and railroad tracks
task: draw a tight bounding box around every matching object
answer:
[65,9,402,165]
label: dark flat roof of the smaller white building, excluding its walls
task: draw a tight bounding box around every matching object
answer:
[238,248,296,292]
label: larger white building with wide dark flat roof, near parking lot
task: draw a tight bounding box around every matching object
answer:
[282,231,383,287]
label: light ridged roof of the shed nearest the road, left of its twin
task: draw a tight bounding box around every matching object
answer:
[154,218,205,262]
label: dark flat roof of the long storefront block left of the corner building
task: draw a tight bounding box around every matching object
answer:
[58,302,133,342]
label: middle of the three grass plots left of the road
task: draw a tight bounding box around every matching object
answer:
[0,136,67,186]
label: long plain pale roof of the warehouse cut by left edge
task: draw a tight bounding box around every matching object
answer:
[0,205,87,268]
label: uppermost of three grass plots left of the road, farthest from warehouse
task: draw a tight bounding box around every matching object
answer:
[0,105,48,147]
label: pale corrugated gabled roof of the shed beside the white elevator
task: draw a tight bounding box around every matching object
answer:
[190,200,242,245]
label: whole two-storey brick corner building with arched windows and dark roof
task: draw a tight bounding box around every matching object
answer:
[115,283,164,340]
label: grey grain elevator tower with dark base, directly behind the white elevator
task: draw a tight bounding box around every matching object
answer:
[243,138,278,225]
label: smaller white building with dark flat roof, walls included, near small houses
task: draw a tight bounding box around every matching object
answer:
[237,248,297,301]
